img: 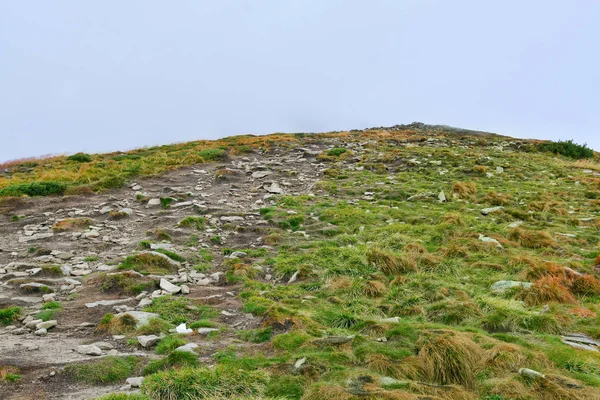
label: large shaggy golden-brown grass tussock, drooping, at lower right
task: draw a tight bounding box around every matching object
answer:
[418,331,480,387]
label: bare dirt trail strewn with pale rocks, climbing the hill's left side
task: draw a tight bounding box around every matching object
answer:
[0,144,325,400]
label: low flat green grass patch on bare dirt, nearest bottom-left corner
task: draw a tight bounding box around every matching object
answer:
[65,356,139,384]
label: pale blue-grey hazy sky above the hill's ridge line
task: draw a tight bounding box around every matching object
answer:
[0,0,600,161]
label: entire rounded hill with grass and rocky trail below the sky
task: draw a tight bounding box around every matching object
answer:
[0,123,600,400]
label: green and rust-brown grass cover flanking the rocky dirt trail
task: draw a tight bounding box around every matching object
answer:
[0,126,600,400]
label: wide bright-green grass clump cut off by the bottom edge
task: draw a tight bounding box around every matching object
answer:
[142,366,268,399]
